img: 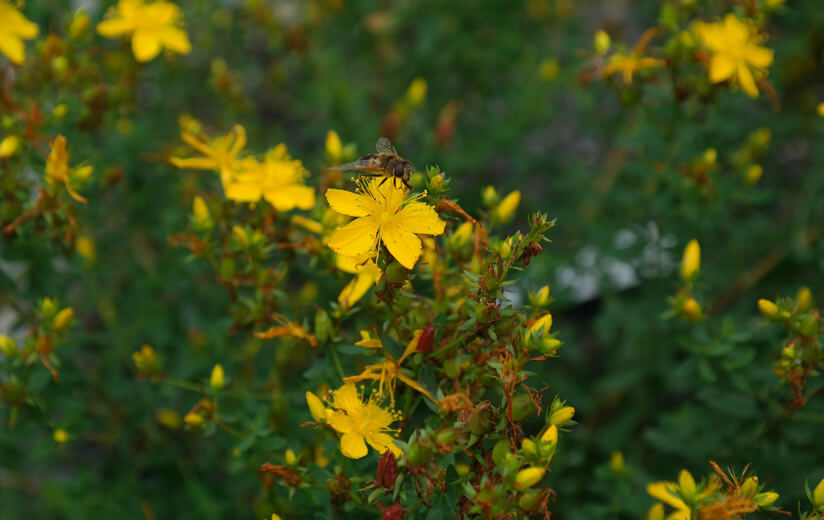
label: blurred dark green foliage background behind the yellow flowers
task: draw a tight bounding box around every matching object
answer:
[0,0,824,519]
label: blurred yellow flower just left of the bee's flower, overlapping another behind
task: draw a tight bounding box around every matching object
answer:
[225,144,315,211]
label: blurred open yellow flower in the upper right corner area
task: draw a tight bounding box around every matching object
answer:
[693,14,773,98]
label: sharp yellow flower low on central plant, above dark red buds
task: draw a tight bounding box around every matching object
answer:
[328,383,401,459]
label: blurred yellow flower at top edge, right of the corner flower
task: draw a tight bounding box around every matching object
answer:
[97,0,192,61]
